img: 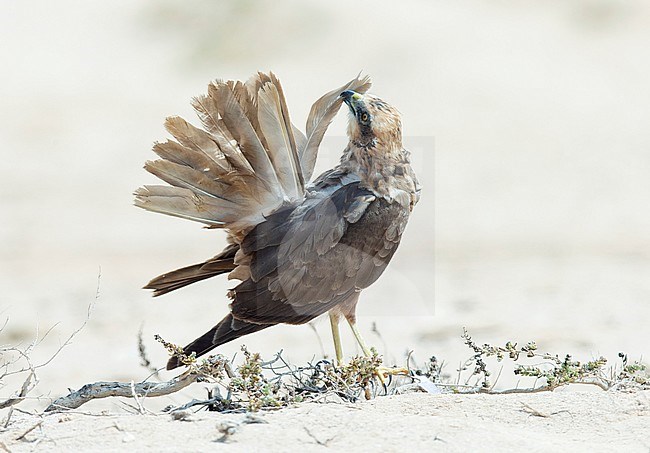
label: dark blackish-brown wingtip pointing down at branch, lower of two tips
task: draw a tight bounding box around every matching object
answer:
[167,314,274,370]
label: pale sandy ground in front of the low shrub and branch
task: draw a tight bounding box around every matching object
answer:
[0,391,650,452]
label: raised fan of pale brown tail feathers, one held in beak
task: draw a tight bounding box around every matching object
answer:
[135,72,370,240]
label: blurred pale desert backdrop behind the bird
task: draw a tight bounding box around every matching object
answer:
[0,0,650,406]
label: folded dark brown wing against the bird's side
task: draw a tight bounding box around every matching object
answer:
[231,182,401,324]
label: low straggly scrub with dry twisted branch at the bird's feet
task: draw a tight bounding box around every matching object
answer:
[7,322,650,416]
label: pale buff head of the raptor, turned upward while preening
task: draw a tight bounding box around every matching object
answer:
[341,90,402,151]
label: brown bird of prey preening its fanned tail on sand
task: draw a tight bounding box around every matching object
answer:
[135,72,420,370]
